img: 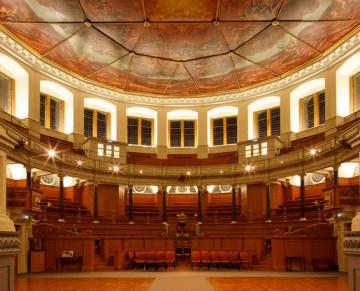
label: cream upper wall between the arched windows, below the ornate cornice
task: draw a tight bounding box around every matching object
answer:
[0,46,360,152]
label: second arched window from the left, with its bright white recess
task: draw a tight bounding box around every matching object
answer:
[40,81,74,133]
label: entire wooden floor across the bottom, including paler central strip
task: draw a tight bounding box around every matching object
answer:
[15,271,348,291]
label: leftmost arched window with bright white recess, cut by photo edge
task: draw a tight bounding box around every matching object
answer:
[0,53,29,118]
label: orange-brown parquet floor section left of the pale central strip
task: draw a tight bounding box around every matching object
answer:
[15,278,154,291]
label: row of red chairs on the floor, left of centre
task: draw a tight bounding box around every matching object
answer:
[127,250,175,270]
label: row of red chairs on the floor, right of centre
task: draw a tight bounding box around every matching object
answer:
[191,250,252,270]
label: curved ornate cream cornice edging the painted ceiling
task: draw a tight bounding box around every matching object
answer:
[0,31,360,106]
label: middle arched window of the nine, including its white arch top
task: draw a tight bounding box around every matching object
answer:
[167,110,198,147]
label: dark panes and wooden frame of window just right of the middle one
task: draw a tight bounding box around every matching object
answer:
[211,116,237,146]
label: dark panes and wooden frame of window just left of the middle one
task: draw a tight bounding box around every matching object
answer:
[127,117,154,146]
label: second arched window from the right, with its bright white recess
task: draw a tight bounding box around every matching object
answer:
[290,78,325,132]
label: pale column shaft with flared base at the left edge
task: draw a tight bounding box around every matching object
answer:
[0,151,15,231]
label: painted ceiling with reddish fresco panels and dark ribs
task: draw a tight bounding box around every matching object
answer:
[0,0,360,96]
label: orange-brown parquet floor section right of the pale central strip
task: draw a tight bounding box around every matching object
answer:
[208,277,348,291]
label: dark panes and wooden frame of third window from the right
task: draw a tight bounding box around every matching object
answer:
[254,107,280,139]
